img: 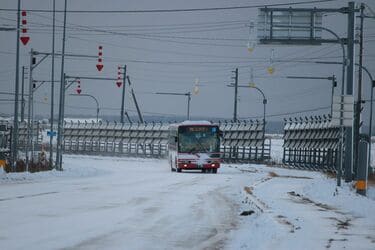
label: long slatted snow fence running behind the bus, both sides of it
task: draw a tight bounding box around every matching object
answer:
[1,120,271,162]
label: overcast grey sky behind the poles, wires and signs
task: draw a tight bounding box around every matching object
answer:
[0,0,375,120]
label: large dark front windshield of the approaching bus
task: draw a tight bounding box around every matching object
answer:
[178,126,220,153]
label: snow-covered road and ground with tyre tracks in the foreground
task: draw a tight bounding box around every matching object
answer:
[0,156,375,249]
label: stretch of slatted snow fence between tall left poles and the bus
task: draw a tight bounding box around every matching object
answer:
[64,122,168,158]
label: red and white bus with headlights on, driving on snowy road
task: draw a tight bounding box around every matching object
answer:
[168,121,221,174]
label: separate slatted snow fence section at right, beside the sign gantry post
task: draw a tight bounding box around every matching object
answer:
[283,115,340,171]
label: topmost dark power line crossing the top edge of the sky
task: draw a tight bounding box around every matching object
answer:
[0,0,337,14]
